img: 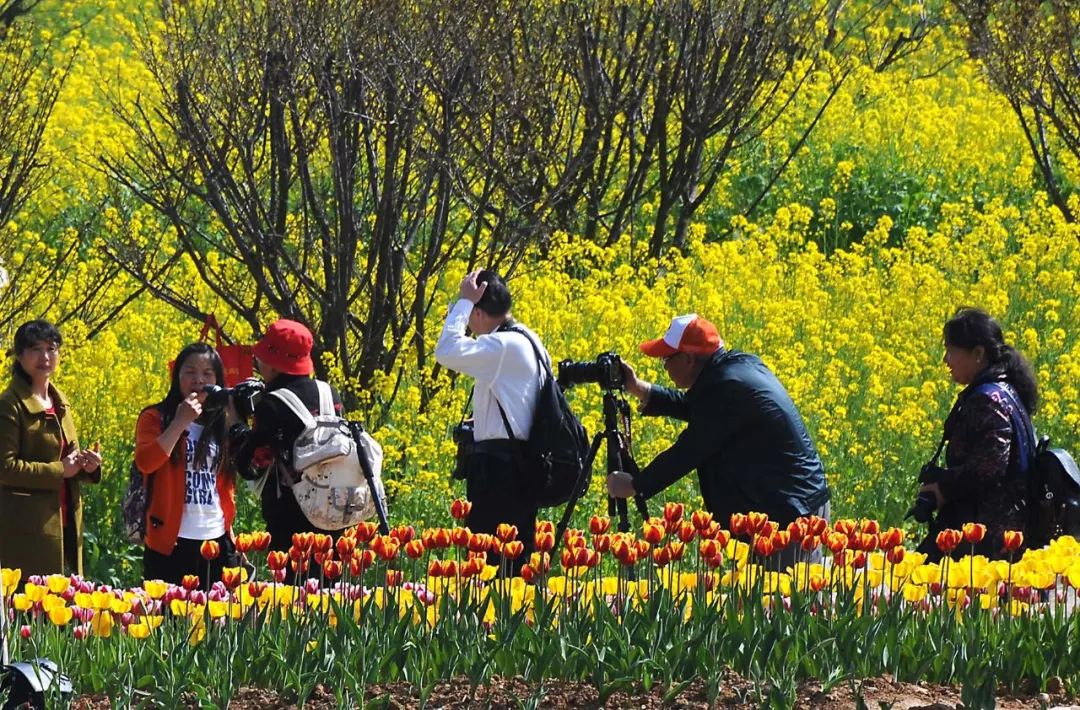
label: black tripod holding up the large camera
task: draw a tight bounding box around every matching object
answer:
[555,389,649,545]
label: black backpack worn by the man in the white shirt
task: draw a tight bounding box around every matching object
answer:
[496,327,589,508]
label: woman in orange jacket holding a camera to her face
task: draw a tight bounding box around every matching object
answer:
[135,343,239,585]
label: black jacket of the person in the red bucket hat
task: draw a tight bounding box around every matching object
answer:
[231,375,341,550]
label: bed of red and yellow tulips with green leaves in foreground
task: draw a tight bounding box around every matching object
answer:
[3,501,1080,707]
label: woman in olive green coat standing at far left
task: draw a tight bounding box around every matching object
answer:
[0,321,102,579]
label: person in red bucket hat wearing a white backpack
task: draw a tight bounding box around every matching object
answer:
[230,319,342,550]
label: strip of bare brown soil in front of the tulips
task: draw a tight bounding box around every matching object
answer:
[71,673,1080,710]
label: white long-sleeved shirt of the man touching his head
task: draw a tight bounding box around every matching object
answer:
[435,298,551,441]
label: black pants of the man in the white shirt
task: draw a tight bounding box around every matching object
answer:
[465,449,537,575]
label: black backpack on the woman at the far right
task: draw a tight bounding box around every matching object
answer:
[1027,437,1080,547]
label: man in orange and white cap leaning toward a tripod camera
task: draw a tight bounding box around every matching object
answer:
[607,313,829,565]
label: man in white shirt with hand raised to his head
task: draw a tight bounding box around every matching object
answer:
[435,270,551,572]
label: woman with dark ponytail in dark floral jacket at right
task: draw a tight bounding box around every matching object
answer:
[919,308,1038,561]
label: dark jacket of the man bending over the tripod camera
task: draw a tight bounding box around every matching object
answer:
[635,350,829,525]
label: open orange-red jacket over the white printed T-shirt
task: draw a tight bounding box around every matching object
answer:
[135,406,237,554]
